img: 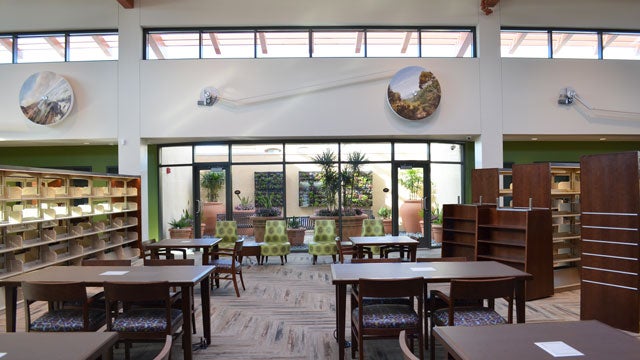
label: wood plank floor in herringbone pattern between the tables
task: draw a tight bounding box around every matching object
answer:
[0,250,638,360]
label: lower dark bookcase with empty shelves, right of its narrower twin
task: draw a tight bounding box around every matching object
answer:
[476,207,553,300]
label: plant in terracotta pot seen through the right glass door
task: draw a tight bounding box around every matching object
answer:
[398,169,423,233]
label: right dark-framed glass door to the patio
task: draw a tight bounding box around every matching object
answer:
[393,161,431,247]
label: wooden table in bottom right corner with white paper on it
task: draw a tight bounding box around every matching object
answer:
[433,320,640,360]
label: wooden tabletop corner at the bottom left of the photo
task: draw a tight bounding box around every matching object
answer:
[0,332,118,360]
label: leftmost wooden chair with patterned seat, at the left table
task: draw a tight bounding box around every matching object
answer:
[22,282,105,332]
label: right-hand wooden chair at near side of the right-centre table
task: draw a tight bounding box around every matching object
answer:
[429,277,516,359]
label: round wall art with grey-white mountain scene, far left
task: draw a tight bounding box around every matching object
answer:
[20,71,73,125]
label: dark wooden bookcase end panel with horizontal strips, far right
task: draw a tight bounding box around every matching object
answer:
[580,152,640,332]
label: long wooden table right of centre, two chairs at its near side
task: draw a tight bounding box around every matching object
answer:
[331,261,532,359]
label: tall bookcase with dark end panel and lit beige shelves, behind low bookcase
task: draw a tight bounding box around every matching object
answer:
[512,163,581,291]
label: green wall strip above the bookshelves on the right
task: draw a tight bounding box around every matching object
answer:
[503,141,640,167]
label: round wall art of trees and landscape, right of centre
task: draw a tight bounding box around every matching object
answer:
[387,66,440,120]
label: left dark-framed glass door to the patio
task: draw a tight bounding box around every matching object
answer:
[193,163,231,238]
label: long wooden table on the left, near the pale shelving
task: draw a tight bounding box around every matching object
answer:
[0,265,215,360]
